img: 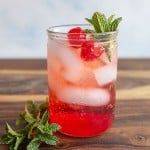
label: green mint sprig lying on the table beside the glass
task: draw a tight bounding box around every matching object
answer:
[0,101,60,150]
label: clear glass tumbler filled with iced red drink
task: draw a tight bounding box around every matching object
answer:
[47,25,117,137]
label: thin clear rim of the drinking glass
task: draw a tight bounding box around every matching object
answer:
[46,24,119,36]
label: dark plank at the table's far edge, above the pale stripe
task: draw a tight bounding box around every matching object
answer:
[0,58,150,70]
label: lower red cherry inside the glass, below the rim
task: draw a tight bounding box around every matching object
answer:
[80,40,103,61]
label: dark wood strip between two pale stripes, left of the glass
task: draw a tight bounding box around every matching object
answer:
[0,74,48,95]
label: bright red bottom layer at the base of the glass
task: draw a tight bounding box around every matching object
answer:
[51,114,114,137]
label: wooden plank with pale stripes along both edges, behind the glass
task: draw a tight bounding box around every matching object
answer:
[0,70,150,101]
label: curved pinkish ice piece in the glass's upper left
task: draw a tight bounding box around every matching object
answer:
[49,43,84,83]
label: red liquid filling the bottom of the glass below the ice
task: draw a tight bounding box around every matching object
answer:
[49,83,115,137]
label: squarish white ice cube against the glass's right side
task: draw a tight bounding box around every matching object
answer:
[94,64,117,86]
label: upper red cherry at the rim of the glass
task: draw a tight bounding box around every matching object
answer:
[68,27,86,48]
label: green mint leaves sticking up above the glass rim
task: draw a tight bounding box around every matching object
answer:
[85,12,122,33]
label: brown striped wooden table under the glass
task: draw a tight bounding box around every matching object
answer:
[0,59,150,150]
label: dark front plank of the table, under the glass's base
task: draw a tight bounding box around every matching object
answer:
[0,100,150,150]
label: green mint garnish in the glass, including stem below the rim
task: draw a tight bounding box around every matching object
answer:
[84,12,122,62]
